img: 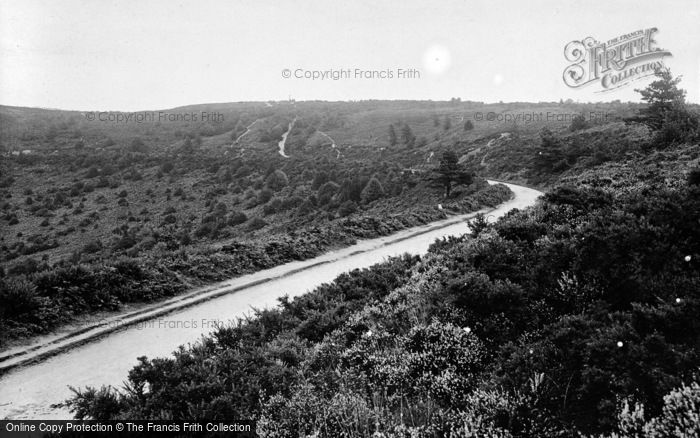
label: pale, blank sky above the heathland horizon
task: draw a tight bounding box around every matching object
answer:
[0,0,700,111]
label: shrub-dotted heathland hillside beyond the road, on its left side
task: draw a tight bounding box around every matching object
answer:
[0,102,524,344]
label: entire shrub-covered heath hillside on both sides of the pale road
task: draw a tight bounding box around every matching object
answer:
[1,75,700,437]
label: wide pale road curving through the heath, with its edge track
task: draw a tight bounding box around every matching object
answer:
[0,181,542,420]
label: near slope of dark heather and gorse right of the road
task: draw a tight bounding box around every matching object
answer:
[57,72,700,437]
